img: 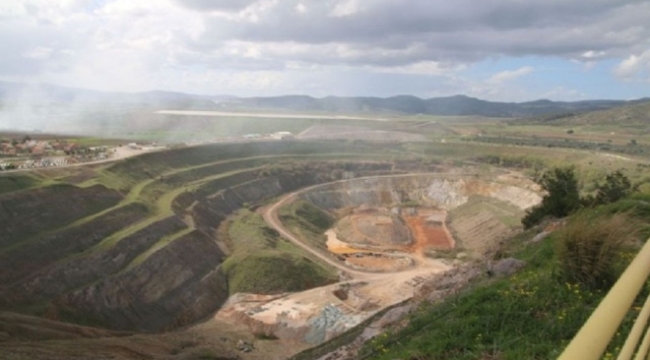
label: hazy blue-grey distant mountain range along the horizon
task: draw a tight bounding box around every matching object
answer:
[0,82,650,118]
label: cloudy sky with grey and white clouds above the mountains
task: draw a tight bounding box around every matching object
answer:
[0,0,650,101]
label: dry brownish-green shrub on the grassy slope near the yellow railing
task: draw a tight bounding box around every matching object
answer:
[555,212,639,289]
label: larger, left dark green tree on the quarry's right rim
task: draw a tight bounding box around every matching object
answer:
[521,167,580,229]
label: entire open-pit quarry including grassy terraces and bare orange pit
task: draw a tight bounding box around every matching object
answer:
[0,141,541,359]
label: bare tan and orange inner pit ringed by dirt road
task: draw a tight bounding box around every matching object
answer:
[210,173,541,345]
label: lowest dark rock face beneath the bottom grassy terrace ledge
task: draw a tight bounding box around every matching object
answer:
[61,231,228,331]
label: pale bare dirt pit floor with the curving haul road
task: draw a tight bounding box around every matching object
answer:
[210,183,453,345]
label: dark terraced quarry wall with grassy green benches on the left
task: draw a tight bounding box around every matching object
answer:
[0,142,404,331]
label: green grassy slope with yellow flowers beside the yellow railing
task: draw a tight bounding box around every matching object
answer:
[359,198,650,360]
